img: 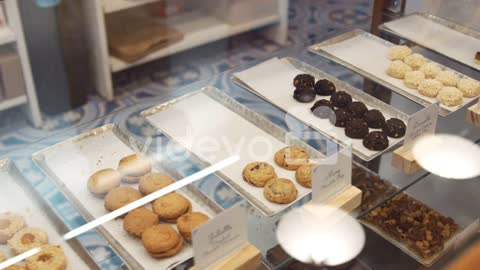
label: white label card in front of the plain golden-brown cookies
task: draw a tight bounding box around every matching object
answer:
[192,203,248,270]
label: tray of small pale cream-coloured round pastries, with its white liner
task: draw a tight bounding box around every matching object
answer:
[309,29,480,116]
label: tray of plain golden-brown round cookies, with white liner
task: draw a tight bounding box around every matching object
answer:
[33,124,222,269]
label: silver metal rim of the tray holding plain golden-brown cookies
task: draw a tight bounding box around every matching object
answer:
[32,124,223,269]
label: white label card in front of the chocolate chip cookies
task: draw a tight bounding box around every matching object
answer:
[312,147,352,204]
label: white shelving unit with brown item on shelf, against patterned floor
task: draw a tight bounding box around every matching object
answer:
[84,0,288,100]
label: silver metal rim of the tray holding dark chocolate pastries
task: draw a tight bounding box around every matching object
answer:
[232,57,408,161]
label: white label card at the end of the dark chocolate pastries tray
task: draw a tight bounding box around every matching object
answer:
[403,103,439,152]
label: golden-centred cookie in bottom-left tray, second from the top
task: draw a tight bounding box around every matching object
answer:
[7,228,48,254]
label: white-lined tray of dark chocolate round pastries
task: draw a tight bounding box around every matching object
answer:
[233,57,408,161]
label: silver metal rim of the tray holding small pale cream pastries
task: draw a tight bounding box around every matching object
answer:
[308,29,475,116]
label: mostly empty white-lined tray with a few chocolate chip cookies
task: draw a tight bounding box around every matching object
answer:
[142,87,334,216]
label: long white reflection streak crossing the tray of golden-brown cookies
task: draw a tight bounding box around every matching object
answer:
[63,156,240,240]
